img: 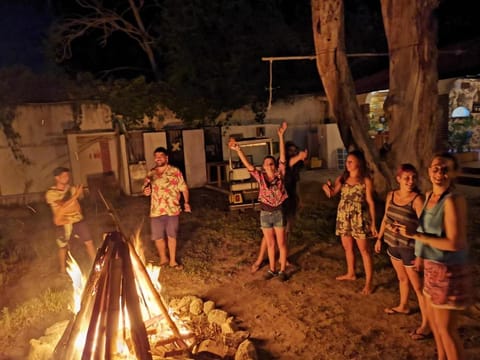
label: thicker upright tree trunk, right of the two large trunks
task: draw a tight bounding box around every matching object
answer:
[381,0,439,188]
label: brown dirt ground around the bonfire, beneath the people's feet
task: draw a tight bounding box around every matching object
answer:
[0,175,480,360]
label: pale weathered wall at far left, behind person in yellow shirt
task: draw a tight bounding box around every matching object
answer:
[0,102,111,203]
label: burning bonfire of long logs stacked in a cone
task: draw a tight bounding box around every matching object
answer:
[54,232,195,359]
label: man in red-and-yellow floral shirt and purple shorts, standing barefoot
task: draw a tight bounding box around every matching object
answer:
[143,147,191,270]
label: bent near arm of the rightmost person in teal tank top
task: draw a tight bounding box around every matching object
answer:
[397,196,467,251]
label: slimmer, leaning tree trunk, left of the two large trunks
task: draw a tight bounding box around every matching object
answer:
[312,0,392,192]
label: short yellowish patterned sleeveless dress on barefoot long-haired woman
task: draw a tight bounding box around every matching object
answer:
[335,183,371,239]
